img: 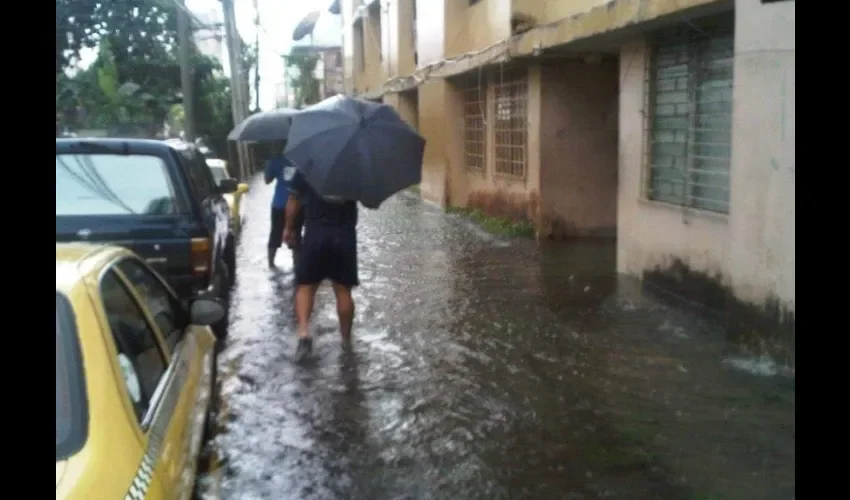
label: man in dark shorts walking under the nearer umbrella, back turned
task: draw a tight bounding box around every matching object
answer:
[284,170,360,362]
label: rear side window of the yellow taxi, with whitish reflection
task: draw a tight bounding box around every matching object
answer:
[100,271,166,422]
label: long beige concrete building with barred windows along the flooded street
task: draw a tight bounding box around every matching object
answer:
[338,0,795,344]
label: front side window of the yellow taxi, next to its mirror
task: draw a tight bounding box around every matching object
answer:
[118,259,189,353]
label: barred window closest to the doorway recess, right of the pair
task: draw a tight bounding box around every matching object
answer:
[492,68,528,178]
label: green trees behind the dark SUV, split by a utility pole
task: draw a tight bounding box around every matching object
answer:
[56,0,233,150]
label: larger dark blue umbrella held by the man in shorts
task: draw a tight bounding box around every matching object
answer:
[284,96,425,208]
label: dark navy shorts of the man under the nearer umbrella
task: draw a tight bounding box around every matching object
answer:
[295,221,360,287]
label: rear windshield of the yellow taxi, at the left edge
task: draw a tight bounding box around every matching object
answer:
[56,292,88,461]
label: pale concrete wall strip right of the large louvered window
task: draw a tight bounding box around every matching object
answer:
[729,0,796,311]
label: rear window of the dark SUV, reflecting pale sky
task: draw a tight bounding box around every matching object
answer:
[56,153,178,215]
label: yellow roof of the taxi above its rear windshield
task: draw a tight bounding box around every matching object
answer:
[56,243,129,295]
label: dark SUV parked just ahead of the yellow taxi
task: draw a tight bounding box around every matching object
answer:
[56,138,237,312]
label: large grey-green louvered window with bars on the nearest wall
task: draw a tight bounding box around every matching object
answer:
[647,18,735,213]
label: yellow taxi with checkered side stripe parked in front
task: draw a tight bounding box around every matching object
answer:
[56,243,225,500]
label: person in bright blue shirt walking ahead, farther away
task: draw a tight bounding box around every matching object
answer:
[263,143,304,268]
